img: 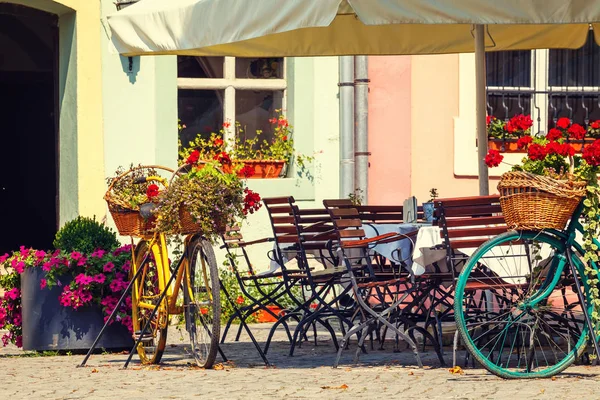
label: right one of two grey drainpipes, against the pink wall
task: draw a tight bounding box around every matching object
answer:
[354,56,370,204]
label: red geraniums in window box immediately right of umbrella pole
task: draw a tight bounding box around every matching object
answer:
[487,114,533,153]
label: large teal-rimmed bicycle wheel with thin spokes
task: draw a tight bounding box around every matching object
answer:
[454,231,592,378]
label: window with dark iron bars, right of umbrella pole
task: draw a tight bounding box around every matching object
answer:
[486,31,600,132]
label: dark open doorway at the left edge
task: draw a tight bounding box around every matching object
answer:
[0,3,58,255]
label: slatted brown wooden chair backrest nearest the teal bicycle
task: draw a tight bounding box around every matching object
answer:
[434,195,508,250]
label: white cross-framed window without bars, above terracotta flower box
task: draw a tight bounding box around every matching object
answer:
[177,56,287,152]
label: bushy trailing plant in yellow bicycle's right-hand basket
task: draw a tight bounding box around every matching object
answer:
[153,158,262,239]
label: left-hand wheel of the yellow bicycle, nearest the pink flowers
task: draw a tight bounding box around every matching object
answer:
[130,240,169,364]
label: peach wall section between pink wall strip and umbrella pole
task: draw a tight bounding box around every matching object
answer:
[411,54,499,201]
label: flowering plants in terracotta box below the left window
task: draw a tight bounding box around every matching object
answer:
[179,110,313,179]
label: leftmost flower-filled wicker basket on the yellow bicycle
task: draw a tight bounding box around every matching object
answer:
[104,165,173,237]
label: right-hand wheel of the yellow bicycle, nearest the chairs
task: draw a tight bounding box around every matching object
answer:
[183,236,221,368]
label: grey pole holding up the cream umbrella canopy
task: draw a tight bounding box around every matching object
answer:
[475,25,490,196]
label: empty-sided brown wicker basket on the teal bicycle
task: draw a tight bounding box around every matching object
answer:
[498,171,587,230]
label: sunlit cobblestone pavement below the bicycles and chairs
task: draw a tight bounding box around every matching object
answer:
[0,324,600,400]
